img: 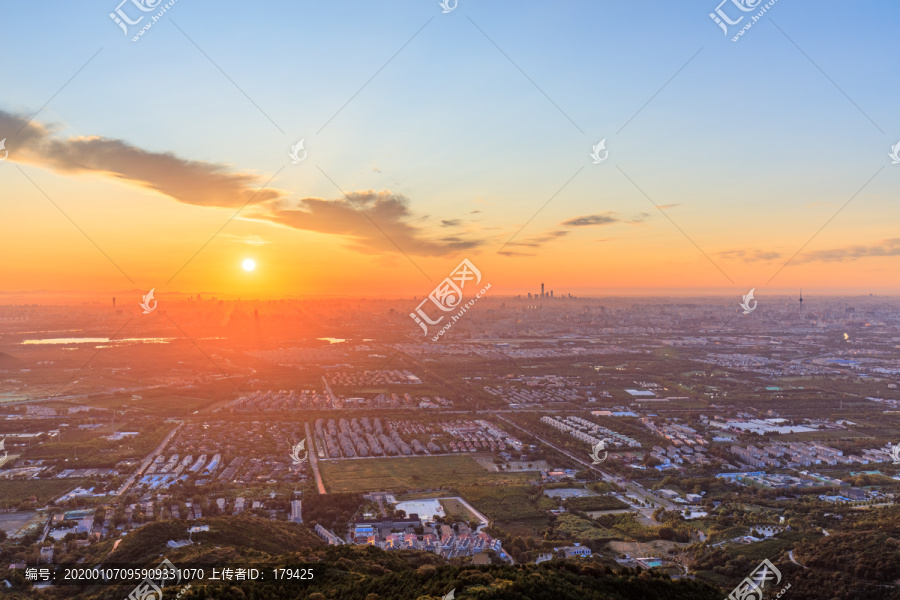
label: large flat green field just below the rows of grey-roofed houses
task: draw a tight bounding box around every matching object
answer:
[319,456,534,493]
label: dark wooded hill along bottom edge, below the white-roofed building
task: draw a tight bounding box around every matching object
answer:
[33,544,722,600]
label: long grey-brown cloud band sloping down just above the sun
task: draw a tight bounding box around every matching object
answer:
[0,111,492,256]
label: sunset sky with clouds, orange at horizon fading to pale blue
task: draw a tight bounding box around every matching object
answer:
[0,5,900,298]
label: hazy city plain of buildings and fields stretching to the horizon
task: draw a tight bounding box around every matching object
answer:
[0,292,900,597]
